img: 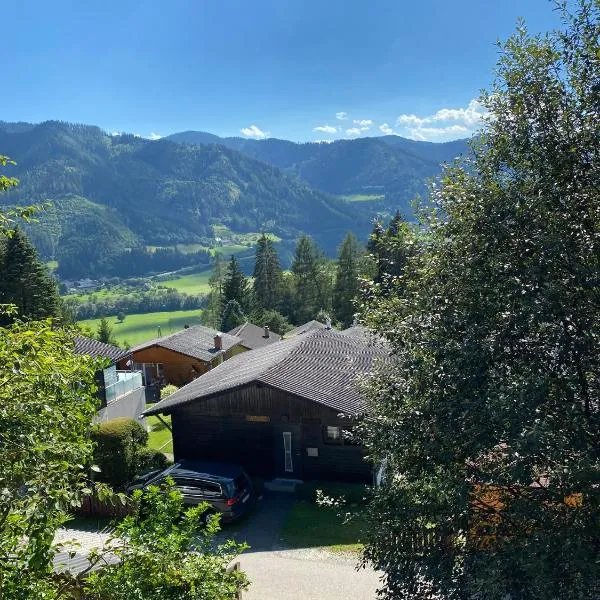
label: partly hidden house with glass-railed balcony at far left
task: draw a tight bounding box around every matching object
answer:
[75,336,146,423]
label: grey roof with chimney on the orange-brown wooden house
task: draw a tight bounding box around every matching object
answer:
[131,325,242,362]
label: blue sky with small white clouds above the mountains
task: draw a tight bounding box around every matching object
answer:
[0,0,558,141]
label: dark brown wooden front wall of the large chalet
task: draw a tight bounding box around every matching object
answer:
[172,384,372,482]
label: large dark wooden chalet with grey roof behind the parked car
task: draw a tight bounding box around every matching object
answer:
[144,329,388,482]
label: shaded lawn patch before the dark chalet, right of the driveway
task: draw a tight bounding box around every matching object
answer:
[281,484,365,552]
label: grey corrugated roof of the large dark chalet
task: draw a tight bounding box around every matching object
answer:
[145,330,389,415]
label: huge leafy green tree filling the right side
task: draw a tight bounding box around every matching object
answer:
[362,2,600,600]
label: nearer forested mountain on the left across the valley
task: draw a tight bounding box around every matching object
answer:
[0,121,373,275]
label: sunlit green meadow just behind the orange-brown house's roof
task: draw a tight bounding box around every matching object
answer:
[79,309,202,346]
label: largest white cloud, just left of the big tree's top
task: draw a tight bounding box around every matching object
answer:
[394,100,486,142]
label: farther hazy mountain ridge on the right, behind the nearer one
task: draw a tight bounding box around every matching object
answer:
[167,131,469,207]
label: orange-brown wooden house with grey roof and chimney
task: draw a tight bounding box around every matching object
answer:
[120,325,246,386]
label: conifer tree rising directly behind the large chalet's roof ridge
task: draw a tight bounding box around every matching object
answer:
[333,233,363,327]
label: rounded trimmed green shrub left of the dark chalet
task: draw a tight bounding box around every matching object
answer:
[92,417,148,489]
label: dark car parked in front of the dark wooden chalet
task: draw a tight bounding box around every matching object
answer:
[127,461,255,521]
